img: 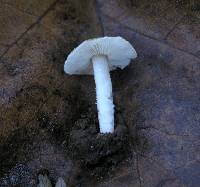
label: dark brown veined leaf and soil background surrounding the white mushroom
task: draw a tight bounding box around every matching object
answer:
[0,0,200,187]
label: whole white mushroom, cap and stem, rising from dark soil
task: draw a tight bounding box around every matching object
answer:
[64,37,137,133]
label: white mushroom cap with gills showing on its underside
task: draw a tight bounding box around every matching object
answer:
[64,36,137,74]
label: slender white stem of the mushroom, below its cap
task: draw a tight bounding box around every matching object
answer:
[92,56,114,133]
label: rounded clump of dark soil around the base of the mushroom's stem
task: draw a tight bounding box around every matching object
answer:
[68,110,130,183]
